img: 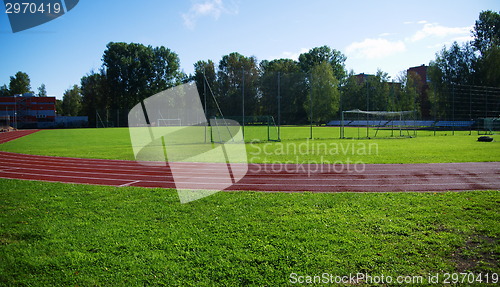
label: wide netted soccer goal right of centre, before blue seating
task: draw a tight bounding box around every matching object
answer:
[340,109,418,139]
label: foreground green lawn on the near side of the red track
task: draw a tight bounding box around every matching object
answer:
[0,179,500,286]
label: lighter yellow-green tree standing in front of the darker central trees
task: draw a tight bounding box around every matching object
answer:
[304,61,340,125]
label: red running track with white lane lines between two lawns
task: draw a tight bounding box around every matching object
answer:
[0,152,500,192]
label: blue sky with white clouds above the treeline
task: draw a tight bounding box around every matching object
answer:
[0,0,500,98]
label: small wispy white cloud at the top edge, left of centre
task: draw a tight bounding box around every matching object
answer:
[182,0,238,29]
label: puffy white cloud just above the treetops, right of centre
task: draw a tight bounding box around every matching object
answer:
[346,38,406,59]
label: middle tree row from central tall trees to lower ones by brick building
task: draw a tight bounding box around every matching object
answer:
[193,46,434,124]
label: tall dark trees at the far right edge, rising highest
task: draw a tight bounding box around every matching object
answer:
[428,11,500,119]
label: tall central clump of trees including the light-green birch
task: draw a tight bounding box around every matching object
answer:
[193,46,352,123]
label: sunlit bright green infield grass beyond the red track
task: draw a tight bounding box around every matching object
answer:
[0,127,500,163]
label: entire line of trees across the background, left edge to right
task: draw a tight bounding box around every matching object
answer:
[0,11,500,124]
